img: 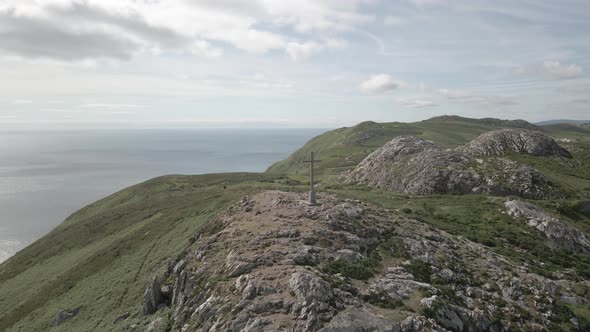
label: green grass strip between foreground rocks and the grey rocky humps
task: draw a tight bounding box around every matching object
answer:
[329,185,590,278]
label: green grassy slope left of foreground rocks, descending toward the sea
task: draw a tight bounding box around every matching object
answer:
[0,174,288,331]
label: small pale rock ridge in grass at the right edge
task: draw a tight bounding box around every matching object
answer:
[505,200,590,253]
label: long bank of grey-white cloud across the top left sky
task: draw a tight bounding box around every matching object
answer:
[0,0,374,61]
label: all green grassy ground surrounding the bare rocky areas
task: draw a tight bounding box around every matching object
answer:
[0,116,590,331]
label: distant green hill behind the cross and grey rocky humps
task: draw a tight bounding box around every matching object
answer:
[268,116,542,174]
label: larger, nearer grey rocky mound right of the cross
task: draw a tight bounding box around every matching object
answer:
[341,136,564,199]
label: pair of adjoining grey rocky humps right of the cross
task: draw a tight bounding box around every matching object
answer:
[341,129,570,199]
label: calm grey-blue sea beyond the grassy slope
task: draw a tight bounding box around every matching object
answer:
[0,129,326,262]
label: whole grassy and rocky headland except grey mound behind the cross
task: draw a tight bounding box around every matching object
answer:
[0,116,590,332]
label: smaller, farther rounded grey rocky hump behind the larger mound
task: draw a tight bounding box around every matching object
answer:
[462,129,571,158]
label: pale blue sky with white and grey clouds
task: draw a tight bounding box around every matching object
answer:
[0,0,590,129]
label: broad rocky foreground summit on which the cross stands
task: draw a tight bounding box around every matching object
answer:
[155,191,578,332]
